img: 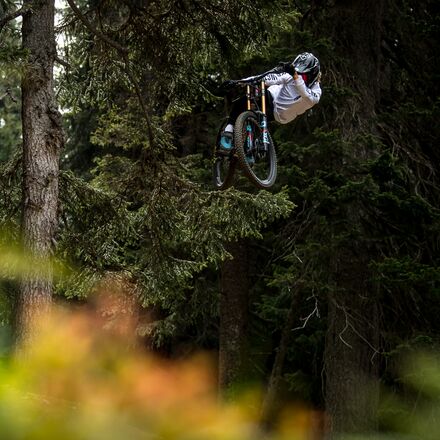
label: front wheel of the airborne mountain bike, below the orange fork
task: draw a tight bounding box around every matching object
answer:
[234,111,277,188]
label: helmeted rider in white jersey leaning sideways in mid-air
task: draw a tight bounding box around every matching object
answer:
[220,52,321,150]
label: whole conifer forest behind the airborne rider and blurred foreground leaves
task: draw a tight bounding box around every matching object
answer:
[0,0,440,438]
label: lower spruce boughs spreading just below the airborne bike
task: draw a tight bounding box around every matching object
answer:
[58,162,293,344]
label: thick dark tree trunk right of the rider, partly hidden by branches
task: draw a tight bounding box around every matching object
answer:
[324,0,385,433]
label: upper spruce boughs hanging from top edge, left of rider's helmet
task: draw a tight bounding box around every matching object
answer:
[58,0,291,113]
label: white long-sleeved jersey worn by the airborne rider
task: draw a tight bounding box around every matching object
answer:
[264,73,322,124]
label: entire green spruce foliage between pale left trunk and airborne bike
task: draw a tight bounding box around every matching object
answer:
[51,1,297,348]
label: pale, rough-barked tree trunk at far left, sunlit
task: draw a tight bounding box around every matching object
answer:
[16,0,64,342]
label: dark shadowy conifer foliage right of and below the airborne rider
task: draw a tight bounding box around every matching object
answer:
[248,11,440,404]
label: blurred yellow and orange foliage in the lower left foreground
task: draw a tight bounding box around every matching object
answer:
[0,296,313,440]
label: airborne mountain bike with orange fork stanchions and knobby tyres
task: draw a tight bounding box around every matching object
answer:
[213,67,280,190]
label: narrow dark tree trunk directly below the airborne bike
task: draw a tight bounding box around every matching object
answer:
[219,241,249,397]
